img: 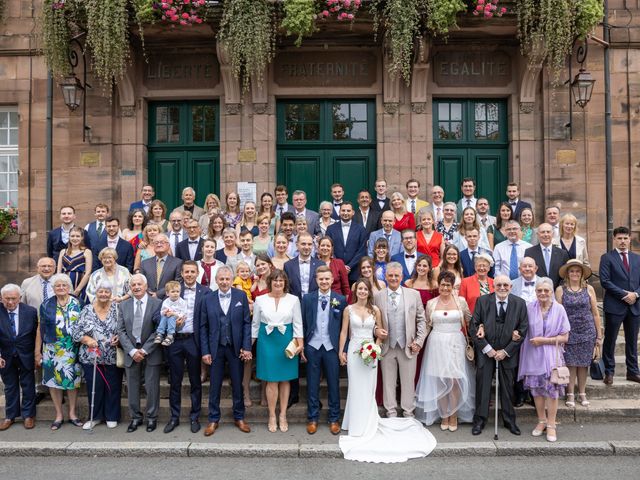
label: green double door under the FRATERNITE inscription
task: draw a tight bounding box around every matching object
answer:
[277,99,376,210]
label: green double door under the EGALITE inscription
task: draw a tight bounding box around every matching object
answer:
[433,99,509,213]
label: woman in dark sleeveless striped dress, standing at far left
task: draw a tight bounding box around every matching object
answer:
[57,227,93,304]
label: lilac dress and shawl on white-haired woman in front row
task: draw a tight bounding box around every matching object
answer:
[518,300,571,398]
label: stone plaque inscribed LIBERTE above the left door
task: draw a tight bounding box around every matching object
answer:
[143,54,220,89]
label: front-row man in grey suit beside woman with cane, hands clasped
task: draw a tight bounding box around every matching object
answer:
[118,273,162,433]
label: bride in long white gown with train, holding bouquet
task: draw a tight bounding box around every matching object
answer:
[339,279,436,463]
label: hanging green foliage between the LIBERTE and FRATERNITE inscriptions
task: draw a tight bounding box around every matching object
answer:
[218,0,275,91]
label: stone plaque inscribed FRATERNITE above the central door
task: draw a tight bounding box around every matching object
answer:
[274,52,377,87]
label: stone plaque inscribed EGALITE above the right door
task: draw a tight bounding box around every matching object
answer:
[433,51,511,87]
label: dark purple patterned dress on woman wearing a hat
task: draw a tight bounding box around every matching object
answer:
[562,287,596,367]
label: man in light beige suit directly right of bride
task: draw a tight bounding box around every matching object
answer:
[373,262,426,417]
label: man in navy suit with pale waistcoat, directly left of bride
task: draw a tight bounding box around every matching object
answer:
[302,265,347,435]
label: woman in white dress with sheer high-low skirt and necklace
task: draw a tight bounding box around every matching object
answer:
[416,271,475,432]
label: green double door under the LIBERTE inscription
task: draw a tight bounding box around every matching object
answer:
[148,101,220,211]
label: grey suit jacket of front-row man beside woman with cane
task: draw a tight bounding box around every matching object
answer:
[118,295,162,367]
